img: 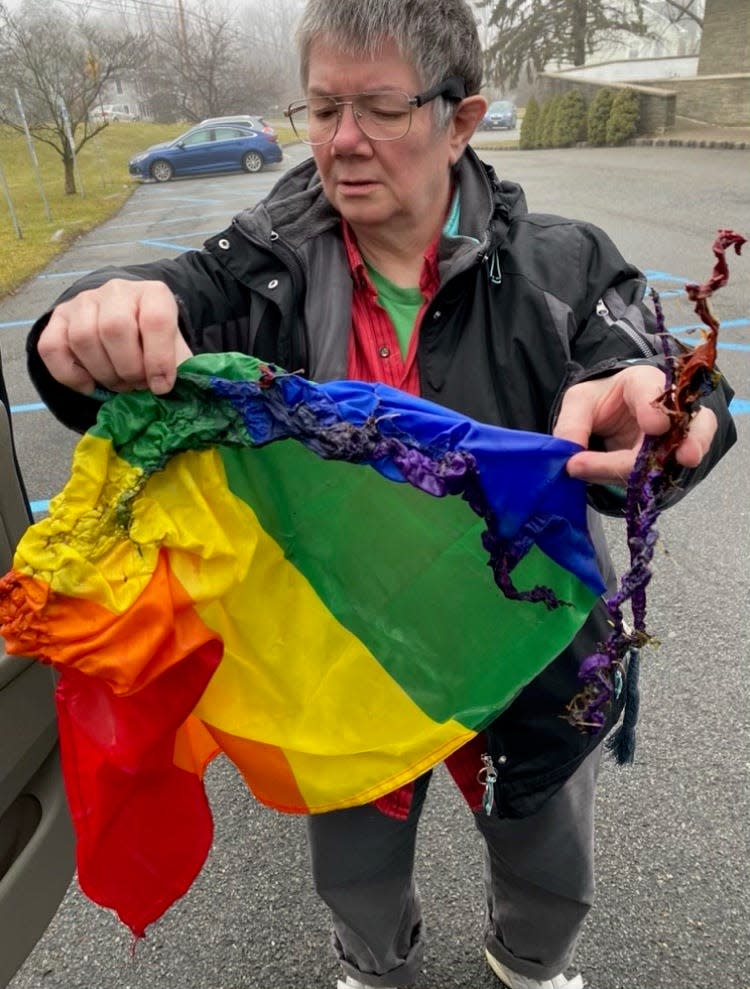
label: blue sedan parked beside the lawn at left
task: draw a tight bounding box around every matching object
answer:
[128,123,282,182]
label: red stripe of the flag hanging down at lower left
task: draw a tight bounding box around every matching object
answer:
[56,640,222,937]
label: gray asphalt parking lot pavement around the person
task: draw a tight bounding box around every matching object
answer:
[0,141,750,989]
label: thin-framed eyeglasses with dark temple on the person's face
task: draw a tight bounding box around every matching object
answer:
[284,76,466,145]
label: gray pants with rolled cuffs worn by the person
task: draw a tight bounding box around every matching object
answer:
[308,746,601,987]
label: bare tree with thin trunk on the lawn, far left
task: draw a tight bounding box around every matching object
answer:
[0,0,139,195]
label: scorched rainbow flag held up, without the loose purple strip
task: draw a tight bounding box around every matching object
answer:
[0,354,603,935]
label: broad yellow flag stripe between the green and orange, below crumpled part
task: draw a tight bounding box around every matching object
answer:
[145,450,474,810]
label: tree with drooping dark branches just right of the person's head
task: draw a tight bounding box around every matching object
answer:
[478,0,648,88]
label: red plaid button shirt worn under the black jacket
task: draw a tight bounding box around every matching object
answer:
[342,221,486,820]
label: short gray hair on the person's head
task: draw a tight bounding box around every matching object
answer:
[297,0,482,126]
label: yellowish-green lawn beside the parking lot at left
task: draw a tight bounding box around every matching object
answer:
[0,121,291,298]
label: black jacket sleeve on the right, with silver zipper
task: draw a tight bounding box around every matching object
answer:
[552,224,737,515]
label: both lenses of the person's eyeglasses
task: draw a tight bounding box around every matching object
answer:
[290,92,412,144]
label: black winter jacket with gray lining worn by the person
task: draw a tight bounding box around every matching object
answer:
[28,145,735,817]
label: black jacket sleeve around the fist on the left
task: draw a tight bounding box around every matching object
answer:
[26,243,258,432]
